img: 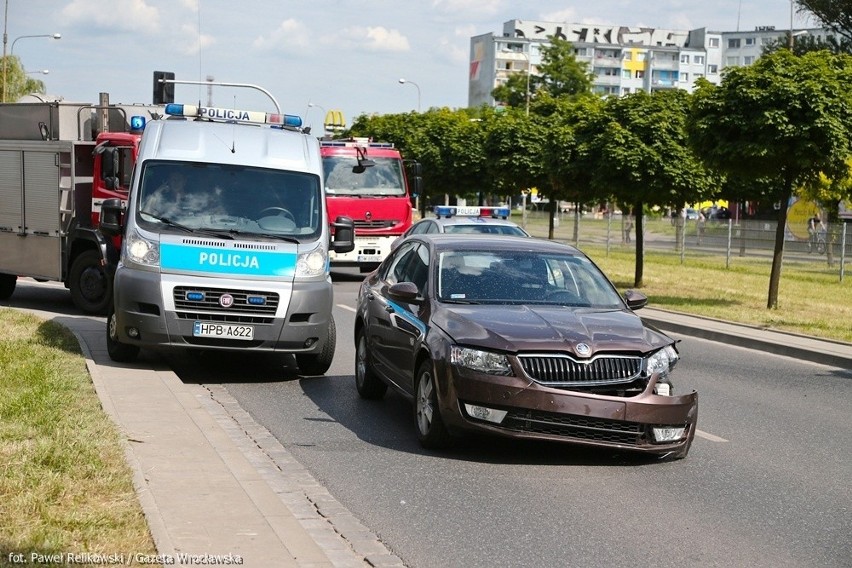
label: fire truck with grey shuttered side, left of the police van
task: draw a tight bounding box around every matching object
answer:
[0,94,155,313]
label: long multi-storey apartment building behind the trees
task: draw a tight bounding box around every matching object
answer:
[468,20,829,107]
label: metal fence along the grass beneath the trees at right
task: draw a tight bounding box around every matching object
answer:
[512,211,852,281]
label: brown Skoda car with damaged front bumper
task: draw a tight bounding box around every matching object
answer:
[354,235,698,458]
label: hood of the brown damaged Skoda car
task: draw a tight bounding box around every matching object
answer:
[433,305,672,355]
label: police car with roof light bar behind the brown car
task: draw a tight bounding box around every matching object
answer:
[391,205,530,248]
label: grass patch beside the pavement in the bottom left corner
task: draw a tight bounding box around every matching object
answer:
[0,309,155,566]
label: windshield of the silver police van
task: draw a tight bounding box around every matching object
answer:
[136,161,323,240]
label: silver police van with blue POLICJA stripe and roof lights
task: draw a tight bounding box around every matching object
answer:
[101,96,354,375]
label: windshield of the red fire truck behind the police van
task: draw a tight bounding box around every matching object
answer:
[322,156,405,197]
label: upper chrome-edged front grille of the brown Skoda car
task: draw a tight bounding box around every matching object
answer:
[518,355,642,387]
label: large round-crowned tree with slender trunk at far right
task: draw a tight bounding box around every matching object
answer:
[687,50,852,308]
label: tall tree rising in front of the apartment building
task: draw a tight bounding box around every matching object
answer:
[530,36,592,97]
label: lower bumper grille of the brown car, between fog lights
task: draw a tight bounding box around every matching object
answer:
[500,410,650,446]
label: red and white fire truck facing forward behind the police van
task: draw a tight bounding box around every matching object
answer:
[320,138,422,272]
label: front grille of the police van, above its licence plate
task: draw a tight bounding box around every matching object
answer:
[173,286,280,324]
